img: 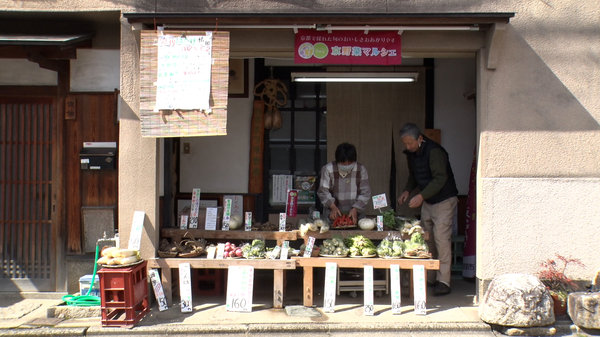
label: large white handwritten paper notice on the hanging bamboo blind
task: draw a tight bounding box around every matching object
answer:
[155,32,212,110]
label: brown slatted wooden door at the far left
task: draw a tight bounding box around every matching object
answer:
[0,97,57,291]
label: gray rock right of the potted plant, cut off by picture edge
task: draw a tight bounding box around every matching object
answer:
[567,292,600,329]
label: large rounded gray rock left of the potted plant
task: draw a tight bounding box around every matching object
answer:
[479,274,555,327]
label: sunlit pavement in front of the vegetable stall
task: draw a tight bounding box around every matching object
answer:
[0,273,571,337]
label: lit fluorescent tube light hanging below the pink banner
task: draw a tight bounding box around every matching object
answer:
[292,72,419,83]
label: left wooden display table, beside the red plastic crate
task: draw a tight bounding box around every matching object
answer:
[148,257,296,308]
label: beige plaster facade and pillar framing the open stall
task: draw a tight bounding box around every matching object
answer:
[3,1,600,289]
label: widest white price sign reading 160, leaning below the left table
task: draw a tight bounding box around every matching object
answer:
[225,266,254,312]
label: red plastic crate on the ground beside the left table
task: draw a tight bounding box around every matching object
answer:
[98,261,150,327]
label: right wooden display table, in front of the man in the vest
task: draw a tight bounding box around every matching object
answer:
[292,257,440,307]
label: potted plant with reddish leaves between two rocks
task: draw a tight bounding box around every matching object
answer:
[538,254,584,316]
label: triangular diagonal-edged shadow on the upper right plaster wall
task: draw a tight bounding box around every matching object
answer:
[487,25,600,131]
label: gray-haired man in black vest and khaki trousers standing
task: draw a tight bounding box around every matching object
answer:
[398,123,458,296]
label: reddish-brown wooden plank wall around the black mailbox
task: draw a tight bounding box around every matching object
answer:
[63,92,119,253]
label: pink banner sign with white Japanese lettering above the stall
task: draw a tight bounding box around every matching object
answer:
[294,29,402,65]
